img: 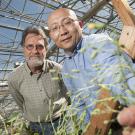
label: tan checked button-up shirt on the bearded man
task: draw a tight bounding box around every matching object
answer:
[8,60,67,122]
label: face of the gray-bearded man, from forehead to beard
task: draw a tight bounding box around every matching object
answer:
[24,33,46,67]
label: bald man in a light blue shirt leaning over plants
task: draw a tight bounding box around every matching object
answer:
[48,8,135,133]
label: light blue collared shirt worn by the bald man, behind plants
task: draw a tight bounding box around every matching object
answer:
[62,34,135,123]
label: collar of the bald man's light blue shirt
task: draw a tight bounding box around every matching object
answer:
[64,38,83,58]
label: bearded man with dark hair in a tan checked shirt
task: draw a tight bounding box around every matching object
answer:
[8,26,67,135]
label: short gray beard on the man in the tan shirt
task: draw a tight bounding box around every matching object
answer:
[26,57,43,68]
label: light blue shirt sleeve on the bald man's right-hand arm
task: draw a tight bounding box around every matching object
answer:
[95,39,135,104]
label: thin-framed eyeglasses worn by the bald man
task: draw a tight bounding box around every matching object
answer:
[50,18,77,34]
